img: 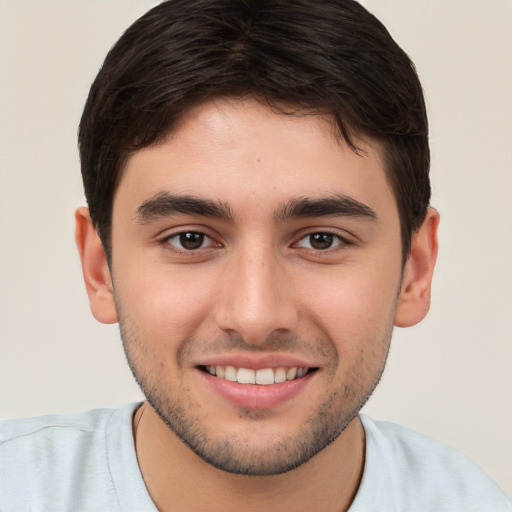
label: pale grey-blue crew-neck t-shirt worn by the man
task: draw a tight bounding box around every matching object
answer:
[0,404,512,512]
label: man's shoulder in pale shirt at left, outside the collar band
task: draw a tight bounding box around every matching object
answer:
[0,404,142,511]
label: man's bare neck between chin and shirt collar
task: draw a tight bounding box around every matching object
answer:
[133,402,365,512]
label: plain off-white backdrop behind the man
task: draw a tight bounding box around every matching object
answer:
[0,0,512,495]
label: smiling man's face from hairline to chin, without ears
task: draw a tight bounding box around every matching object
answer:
[112,100,402,475]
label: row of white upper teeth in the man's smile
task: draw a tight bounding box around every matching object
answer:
[206,365,308,386]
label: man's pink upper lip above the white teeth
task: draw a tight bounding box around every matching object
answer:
[194,353,320,370]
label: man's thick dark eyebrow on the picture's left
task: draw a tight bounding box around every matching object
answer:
[136,192,233,224]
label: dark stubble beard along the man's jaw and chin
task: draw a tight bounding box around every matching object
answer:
[118,311,393,476]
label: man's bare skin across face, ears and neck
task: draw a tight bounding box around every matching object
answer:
[76,100,439,511]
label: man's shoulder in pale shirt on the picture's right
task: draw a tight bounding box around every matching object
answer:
[351,416,512,512]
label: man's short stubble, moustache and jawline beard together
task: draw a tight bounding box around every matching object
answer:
[117,302,395,476]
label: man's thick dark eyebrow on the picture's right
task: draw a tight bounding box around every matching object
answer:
[275,195,377,222]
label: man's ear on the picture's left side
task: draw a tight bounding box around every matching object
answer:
[75,207,117,324]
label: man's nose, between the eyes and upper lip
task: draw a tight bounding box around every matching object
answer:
[215,244,299,345]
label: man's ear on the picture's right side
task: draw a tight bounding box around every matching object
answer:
[395,208,439,327]
